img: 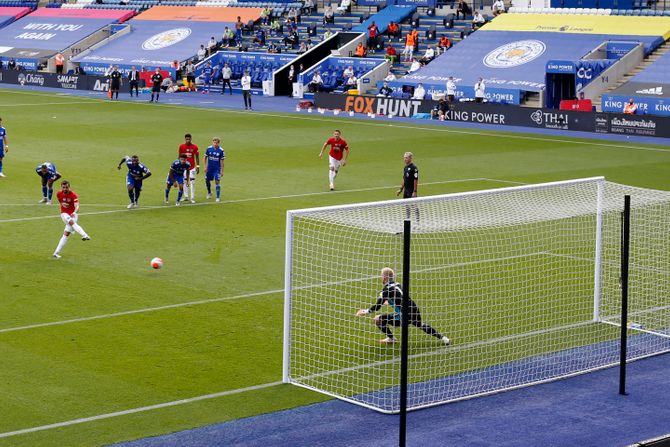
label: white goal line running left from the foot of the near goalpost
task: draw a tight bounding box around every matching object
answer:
[0,381,283,438]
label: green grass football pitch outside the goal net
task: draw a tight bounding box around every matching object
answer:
[0,89,670,446]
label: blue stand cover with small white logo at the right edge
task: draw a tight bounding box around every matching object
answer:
[602,43,670,116]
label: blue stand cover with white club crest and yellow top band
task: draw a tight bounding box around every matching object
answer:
[391,14,670,104]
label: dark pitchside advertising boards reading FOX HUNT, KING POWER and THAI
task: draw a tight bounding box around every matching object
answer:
[314,93,670,138]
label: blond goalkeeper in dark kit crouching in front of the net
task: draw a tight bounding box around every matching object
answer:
[356,267,450,345]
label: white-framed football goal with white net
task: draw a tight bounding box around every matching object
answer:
[283,177,670,413]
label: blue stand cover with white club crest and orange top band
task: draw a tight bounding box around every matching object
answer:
[73,6,261,75]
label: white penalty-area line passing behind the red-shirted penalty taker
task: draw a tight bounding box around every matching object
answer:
[0,178,522,223]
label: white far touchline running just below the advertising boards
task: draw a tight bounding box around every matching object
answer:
[0,90,670,153]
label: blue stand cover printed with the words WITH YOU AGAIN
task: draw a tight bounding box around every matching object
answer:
[0,8,134,70]
